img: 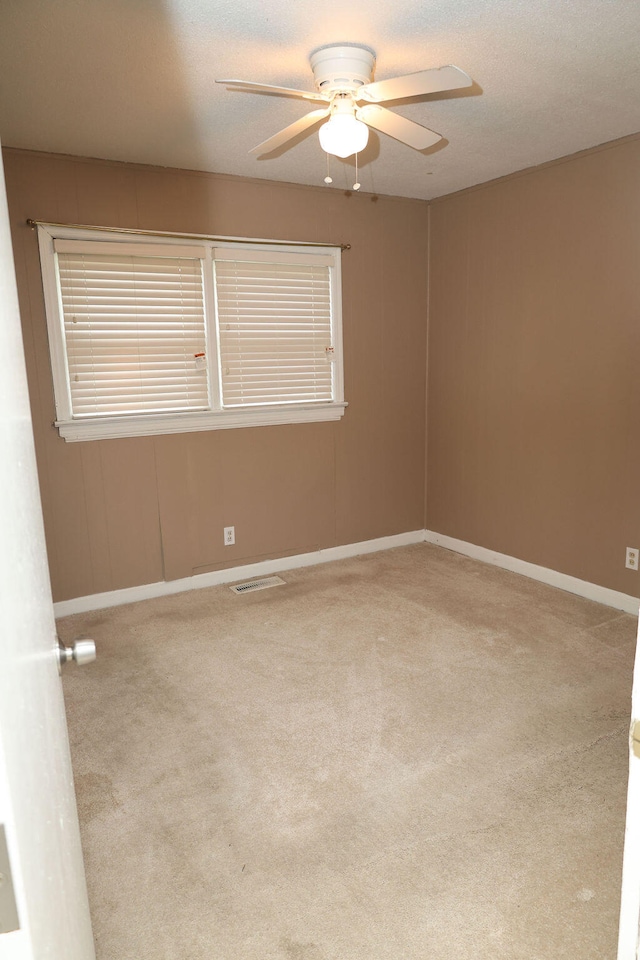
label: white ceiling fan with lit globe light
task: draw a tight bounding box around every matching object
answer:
[216,43,473,158]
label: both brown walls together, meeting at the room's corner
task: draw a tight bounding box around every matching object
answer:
[5,138,640,600]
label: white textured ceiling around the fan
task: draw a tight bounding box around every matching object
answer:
[0,0,640,199]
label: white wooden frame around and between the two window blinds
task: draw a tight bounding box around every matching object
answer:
[37,223,347,441]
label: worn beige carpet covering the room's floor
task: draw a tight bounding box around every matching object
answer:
[59,544,635,960]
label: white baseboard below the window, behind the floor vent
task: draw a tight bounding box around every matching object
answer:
[53,530,424,617]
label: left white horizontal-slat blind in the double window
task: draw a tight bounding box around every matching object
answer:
[54,239,209,418]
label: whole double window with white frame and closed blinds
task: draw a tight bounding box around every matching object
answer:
[38,224,345,440]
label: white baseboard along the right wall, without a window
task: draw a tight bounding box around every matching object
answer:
[425,530,640,617]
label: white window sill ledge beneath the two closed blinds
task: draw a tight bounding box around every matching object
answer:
[54,403,347,443]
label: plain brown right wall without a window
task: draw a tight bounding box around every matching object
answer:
[427,131,640,595]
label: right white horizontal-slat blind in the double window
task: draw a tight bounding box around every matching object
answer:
[214,249,334,407]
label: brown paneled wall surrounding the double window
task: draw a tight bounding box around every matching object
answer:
[4,150,427,600]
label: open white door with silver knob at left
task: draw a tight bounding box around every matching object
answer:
[0,144,95,960]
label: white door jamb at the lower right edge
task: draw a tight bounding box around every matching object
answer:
[618,623,640,960]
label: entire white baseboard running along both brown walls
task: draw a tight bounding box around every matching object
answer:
[53,530,640,617]
